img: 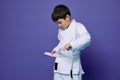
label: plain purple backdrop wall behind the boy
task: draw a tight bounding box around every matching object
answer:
[0,0,120,80]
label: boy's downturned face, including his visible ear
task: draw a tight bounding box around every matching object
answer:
[57,15,71,30]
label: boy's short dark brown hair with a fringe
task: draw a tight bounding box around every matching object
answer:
[51,5,71,21]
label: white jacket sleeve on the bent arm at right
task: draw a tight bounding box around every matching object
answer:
[70,24,91,50]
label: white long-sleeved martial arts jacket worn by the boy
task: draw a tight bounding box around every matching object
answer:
[54,20,91,79]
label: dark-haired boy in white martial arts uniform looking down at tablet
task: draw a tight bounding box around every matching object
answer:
[51,5,91,80]
